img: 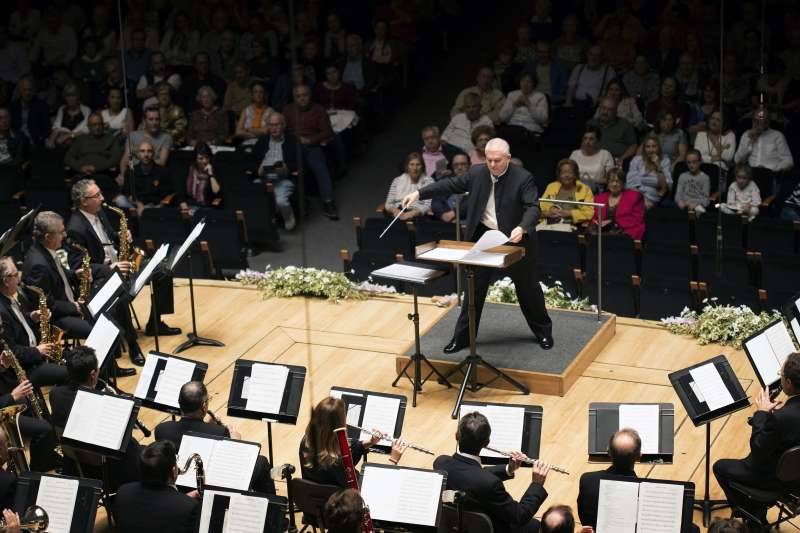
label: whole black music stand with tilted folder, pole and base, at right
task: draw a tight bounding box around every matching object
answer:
[668,355,750,527]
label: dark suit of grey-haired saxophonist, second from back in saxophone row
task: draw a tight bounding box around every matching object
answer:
[22,242,92,339]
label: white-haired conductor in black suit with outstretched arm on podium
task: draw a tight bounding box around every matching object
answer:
[403,138,553,353]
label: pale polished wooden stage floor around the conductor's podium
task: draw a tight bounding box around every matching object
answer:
[104,280,800,531]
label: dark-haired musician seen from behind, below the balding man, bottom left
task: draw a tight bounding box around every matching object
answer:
[114,441,200,533]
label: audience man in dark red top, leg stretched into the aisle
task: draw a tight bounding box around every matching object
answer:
[285,85,339,220]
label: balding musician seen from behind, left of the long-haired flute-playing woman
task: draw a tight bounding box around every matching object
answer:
[155,381,275,494]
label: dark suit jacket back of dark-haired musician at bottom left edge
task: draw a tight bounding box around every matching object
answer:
[114,481,200,533]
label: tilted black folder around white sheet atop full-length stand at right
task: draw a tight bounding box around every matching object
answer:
[668,355,750,426]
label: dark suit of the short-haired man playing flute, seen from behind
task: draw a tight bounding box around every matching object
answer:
[433,454,547,533]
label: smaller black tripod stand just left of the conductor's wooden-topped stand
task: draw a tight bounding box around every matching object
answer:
[371,262,452,407]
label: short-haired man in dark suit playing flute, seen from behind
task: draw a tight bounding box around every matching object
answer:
[433,412,550,533]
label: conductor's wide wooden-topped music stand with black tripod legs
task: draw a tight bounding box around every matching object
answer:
[415,240,530,419]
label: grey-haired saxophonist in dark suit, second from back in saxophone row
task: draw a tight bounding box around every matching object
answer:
[22,211,92,339]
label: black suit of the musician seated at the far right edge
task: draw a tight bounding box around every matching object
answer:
[714,396,800,516]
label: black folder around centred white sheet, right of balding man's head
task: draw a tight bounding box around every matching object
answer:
[228,359,306,424]
